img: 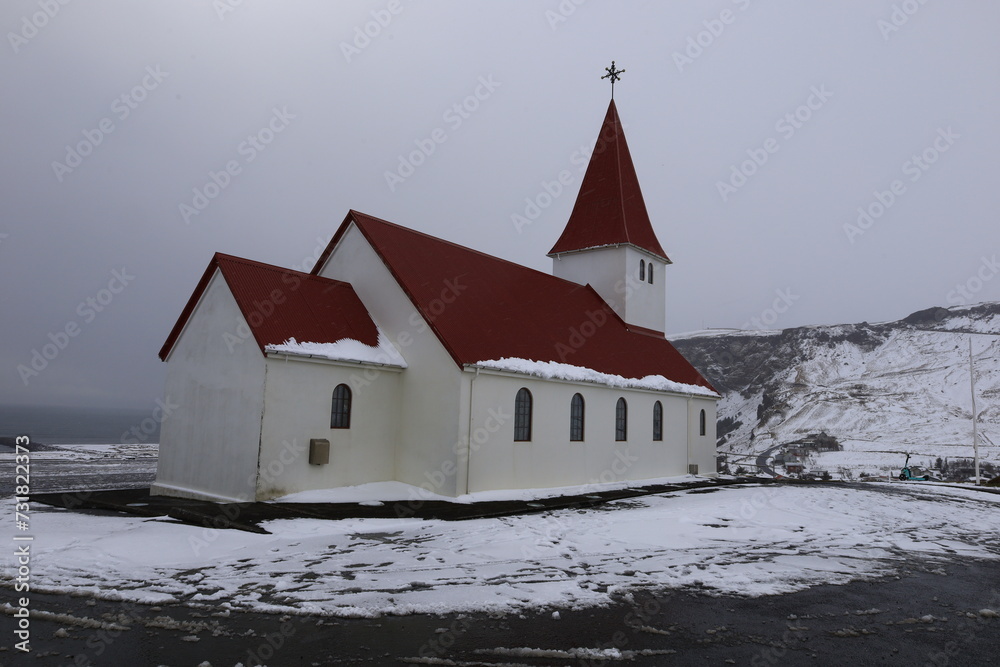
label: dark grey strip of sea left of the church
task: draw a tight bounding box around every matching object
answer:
[0,405,160,445]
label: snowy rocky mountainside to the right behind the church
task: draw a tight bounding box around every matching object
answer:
[673,303,1000,474]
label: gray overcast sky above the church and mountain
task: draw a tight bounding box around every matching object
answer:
[0,0,1000,407]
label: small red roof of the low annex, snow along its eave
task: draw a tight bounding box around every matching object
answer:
[160,253,378,360]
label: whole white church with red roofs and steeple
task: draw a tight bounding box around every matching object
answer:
[153,100,719,501]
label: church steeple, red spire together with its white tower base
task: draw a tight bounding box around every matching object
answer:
[548,94,671,335]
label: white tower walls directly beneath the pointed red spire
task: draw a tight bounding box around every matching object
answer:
[552,246,667,331]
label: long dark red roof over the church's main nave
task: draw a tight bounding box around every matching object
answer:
[313,211,711,388]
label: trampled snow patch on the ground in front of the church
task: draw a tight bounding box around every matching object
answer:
[23,483,1000,616]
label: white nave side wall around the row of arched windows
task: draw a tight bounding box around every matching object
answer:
[467,371,715,491]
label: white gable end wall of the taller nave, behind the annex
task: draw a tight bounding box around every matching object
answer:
[320,224,468,496]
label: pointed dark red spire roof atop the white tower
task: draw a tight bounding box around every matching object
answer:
[549,100,670,262]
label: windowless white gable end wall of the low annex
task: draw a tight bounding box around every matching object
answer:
[152,271,264,500]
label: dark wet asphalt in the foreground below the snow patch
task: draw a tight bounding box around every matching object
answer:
[0,452,1000,667]
